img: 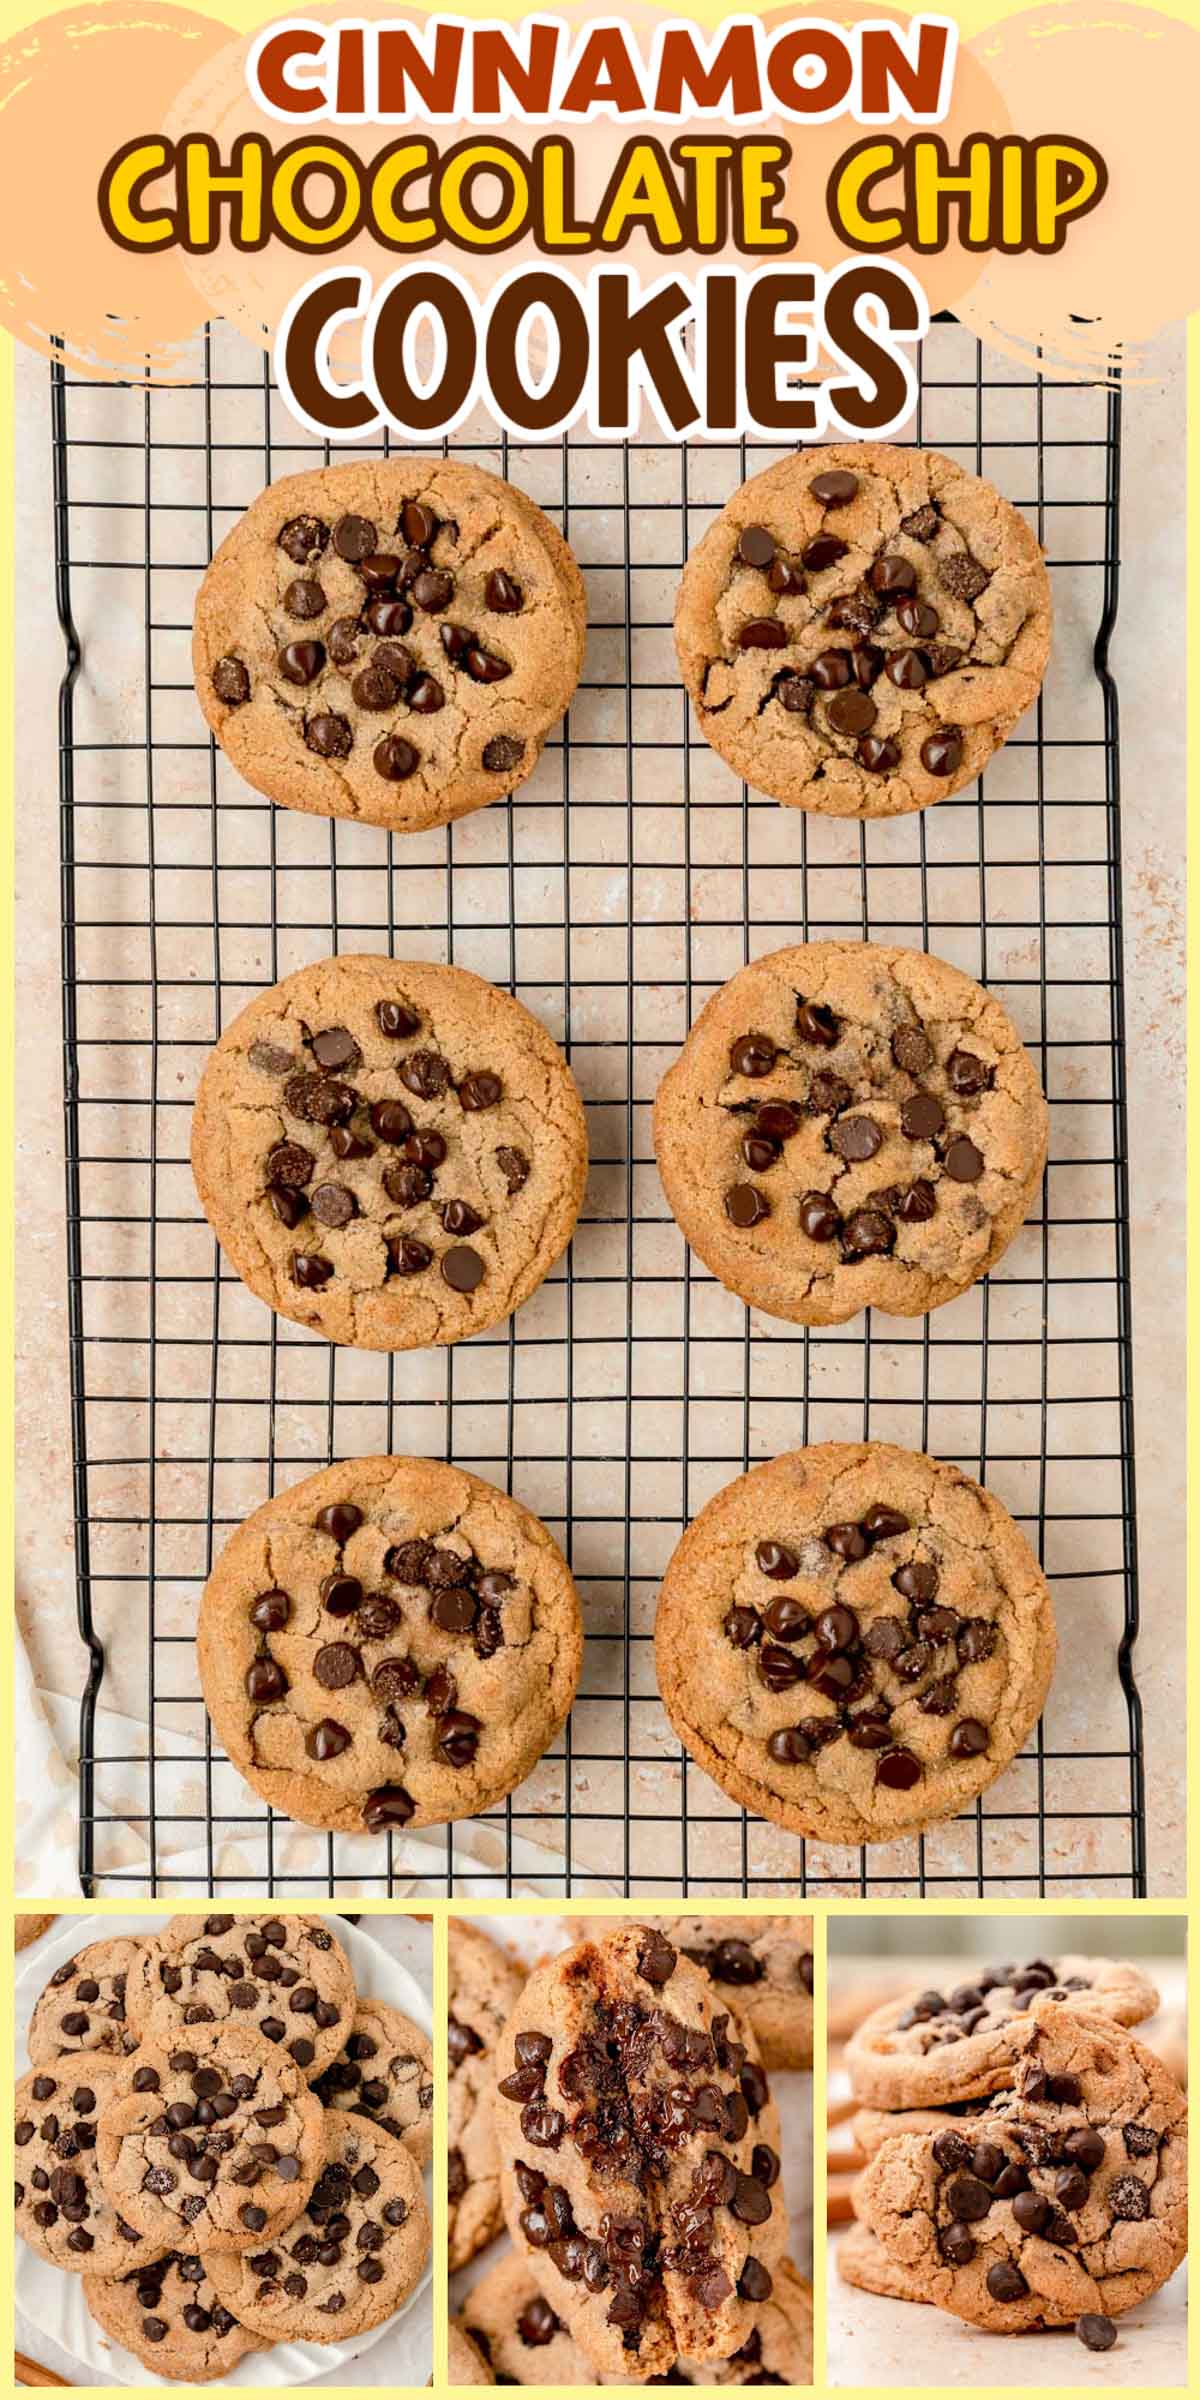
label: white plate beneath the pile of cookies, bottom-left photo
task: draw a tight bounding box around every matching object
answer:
[14,1913,432,2390]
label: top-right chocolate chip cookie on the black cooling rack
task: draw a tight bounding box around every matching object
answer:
[674,442,1051,816]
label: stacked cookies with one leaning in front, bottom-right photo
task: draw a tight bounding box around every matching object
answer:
[838,1956,1188,2350]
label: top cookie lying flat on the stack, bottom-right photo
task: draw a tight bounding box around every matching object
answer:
[845,1956,1159,2110]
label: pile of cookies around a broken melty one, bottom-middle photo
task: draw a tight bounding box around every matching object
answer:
[449,1915,814,2386]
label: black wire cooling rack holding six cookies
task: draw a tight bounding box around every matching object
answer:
[50,322,1145,1898]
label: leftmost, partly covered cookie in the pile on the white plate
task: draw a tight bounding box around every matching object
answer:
[12,2057,161,2275]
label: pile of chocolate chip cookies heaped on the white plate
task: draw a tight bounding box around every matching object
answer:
[14,1915,434,2383]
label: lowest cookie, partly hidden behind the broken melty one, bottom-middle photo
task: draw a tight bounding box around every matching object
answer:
[451,2251,814,2386]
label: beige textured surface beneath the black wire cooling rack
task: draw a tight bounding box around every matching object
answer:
[14,329,1186,1896]
